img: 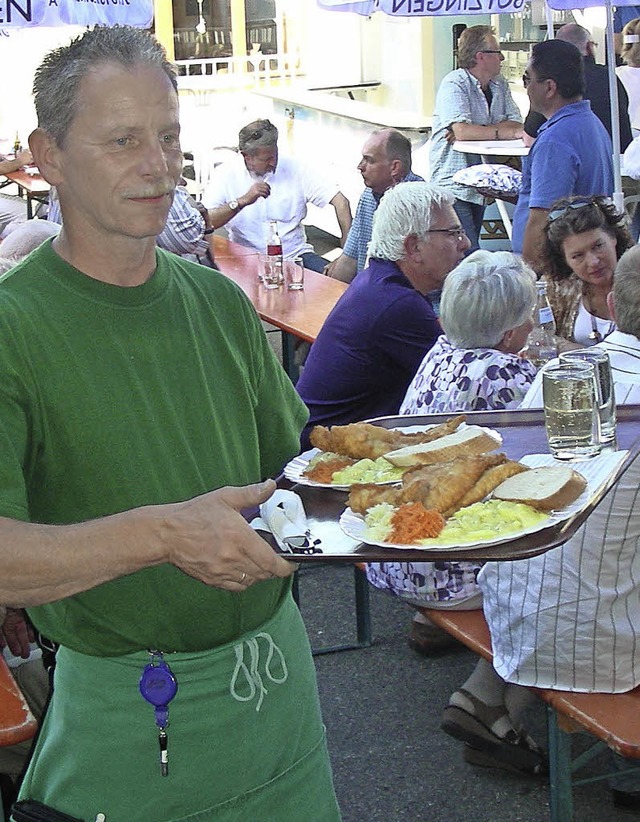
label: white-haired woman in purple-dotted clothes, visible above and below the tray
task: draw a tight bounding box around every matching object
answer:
[367,251,536,655]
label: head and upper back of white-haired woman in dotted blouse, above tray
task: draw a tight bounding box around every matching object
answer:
[400,251,536,414]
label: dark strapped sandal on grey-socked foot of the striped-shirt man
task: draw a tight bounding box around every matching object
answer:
[440,688,547,774]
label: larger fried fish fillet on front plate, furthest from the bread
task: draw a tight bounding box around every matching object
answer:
[348,454,507,514]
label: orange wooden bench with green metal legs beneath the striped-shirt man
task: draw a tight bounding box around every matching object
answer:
[419,608,640,822]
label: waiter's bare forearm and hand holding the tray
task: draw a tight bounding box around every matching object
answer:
[0,480,295,607]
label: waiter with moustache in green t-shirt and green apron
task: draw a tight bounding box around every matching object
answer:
[0,27,339,822]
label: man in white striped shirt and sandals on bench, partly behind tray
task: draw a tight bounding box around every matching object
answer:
[443,246,640,808]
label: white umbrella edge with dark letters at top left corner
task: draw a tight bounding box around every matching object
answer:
[0,0,153,29]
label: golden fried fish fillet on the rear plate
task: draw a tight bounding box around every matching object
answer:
[310,414,465,460]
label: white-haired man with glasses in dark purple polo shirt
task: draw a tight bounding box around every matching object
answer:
[296,182,469,446]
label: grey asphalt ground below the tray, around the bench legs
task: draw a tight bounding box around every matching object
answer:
[300,566,634,822]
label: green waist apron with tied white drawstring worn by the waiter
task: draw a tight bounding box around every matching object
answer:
[20,596,340,822]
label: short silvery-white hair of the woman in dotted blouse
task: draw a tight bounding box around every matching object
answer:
[440,251,536,348]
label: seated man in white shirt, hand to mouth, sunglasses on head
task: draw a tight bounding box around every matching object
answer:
[202,120,351,272]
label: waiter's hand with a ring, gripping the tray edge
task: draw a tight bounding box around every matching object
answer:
[168,480,296,592]
